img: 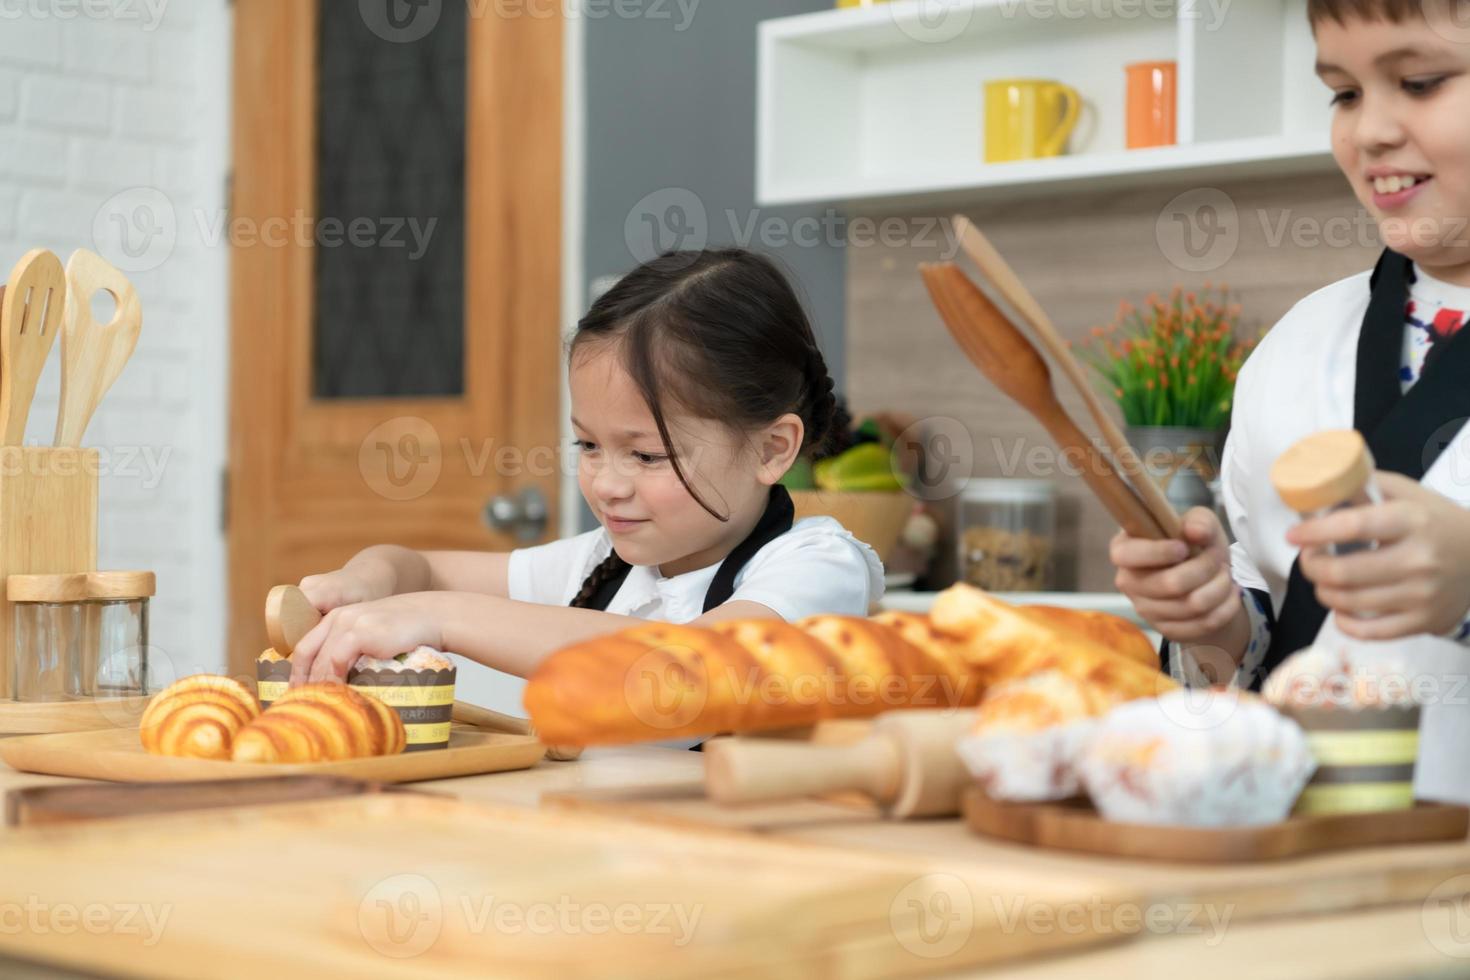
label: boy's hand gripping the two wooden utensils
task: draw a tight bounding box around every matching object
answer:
[1108,507,1244,644]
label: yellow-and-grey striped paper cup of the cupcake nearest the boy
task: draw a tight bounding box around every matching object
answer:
[1282,705,1420,815]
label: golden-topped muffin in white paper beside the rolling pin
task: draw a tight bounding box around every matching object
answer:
[956,670,1114,802]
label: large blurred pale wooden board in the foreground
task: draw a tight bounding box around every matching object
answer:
[0,795,1135,980]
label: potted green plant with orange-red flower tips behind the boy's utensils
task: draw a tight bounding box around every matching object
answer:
[1079,282,1260,513]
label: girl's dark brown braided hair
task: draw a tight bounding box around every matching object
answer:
[569,248,838,605]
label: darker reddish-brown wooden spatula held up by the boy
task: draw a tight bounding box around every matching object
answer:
[919,262,1166,539]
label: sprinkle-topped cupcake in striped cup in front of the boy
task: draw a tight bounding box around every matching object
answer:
[1263,645,1420,814]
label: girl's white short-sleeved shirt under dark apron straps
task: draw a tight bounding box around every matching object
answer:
[510,517,883,623]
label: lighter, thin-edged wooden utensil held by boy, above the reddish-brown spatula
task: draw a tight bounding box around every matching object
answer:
[954,215,1182,538]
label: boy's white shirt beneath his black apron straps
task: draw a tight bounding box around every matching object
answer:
[1176,262,1470,802]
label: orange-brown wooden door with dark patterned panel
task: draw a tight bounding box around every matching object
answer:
[226,0,563,673]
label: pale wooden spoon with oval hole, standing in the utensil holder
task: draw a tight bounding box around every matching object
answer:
[56,248,143,445]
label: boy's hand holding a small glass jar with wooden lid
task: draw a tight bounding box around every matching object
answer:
[1286,472,1470,639]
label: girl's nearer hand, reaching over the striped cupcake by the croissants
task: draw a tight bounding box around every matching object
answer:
[291,586,444,688]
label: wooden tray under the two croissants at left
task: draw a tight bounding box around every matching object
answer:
[0,727,545,783]
